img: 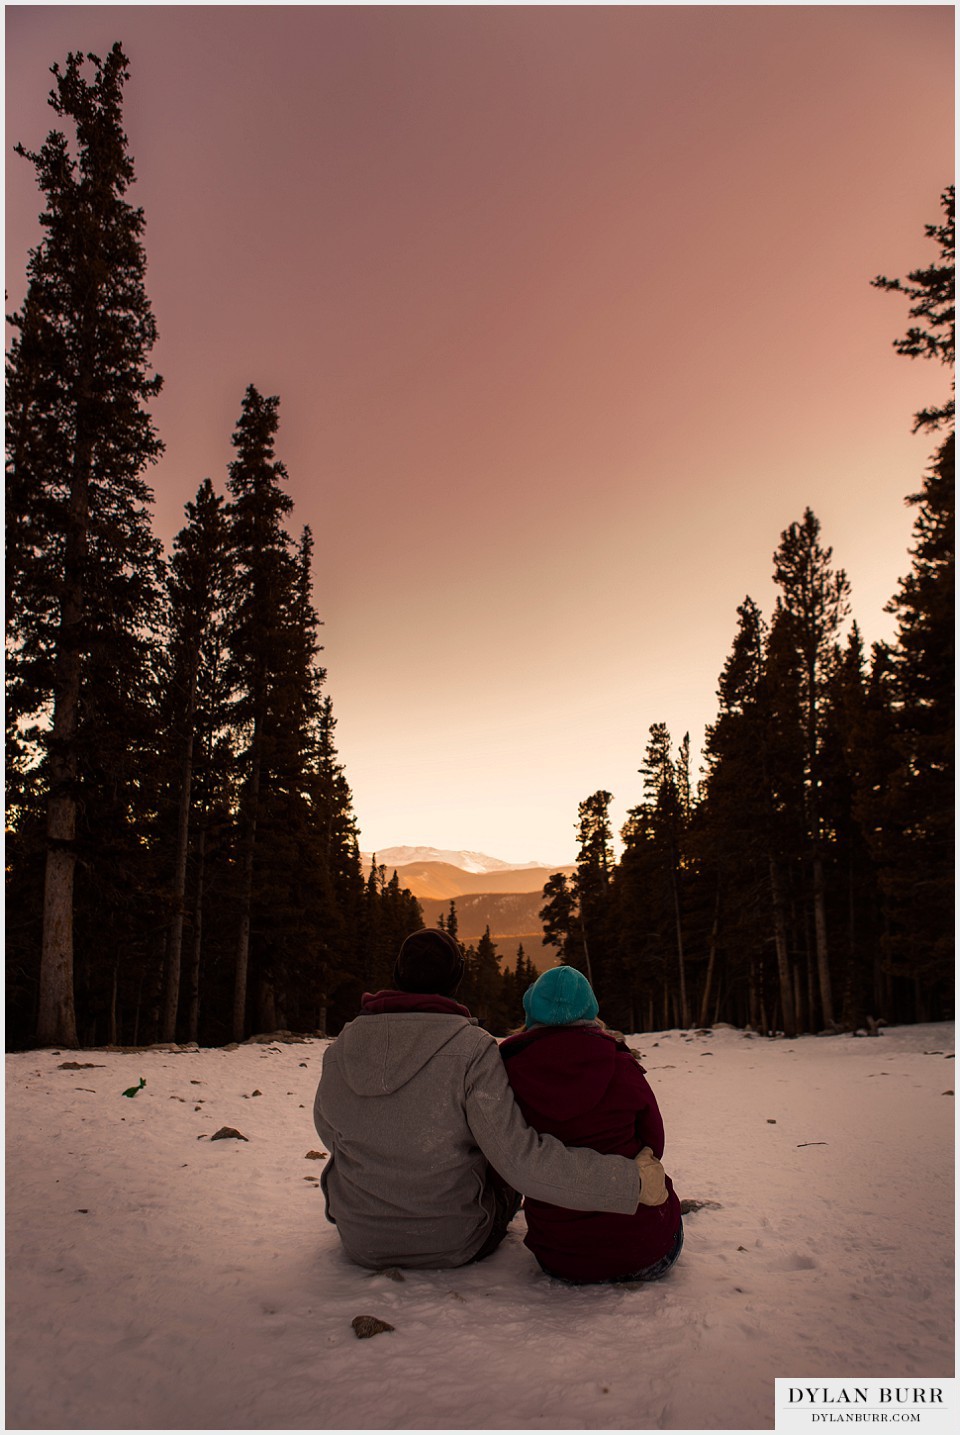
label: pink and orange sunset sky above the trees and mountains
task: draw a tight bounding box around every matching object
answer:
[6,4,954,864]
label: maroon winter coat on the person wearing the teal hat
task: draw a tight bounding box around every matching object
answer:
[499,1026,680,1281]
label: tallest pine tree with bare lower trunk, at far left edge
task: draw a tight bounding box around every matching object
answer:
[7,44,162,1046]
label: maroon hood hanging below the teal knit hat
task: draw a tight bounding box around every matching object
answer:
[499,1026,620,1125]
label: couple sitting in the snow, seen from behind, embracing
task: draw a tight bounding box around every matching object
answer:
[314,930,683,1283]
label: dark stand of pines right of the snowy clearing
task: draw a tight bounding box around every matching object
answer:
[541,188,954,1036]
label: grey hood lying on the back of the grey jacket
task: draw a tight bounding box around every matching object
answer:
[330,993,478,1096]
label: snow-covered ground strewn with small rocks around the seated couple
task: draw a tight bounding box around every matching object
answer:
[6,1025,954,1431]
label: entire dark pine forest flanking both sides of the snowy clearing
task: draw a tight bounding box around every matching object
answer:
[6,44,954,1048]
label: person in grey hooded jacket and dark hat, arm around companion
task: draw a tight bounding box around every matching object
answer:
[313,928,667,1269]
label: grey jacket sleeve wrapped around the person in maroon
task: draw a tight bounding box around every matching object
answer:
[465,1040,640,1215]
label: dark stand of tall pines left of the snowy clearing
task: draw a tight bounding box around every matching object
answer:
[6,44,422,1046]
